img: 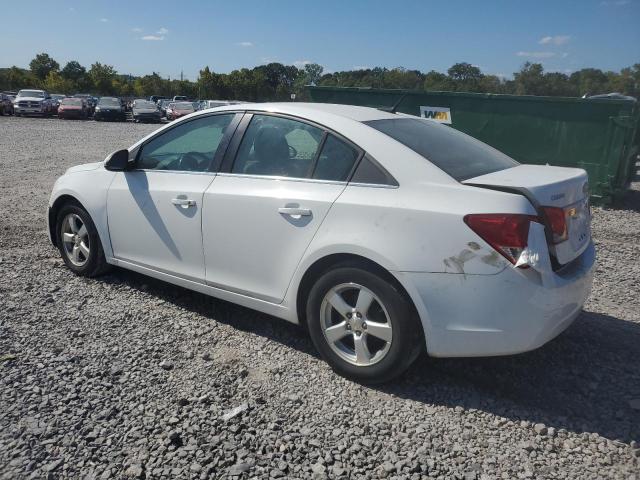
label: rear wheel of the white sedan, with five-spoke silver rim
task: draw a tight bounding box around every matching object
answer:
[306,266,424,384]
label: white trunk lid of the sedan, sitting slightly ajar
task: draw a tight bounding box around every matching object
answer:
[462,165,591,265]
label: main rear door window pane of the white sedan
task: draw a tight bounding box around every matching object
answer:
[232,115,324,178]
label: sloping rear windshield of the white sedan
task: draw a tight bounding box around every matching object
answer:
[364,118,518,182]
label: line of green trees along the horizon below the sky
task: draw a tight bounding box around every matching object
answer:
[0,53,640,102]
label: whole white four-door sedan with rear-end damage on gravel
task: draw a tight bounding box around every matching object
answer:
[48,103,595,382]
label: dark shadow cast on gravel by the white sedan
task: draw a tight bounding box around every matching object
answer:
[100,269,640,443]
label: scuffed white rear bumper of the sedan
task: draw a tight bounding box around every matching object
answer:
[396,243,595,357]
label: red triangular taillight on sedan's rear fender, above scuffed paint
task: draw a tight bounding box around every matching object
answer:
[464,213,540,265]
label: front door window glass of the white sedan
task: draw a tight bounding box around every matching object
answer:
[136,114,234,172]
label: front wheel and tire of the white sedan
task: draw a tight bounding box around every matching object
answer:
[56,203,110,277]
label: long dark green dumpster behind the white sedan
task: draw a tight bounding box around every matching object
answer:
[307,86,640,204]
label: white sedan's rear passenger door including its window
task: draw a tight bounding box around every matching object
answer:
[202,114,362,302]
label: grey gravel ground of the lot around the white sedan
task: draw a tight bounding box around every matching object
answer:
[0,117,640,480]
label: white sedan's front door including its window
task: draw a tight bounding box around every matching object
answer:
[107,114,234,282]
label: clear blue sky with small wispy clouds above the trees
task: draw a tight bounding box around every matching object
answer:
[0,0,640,79]
